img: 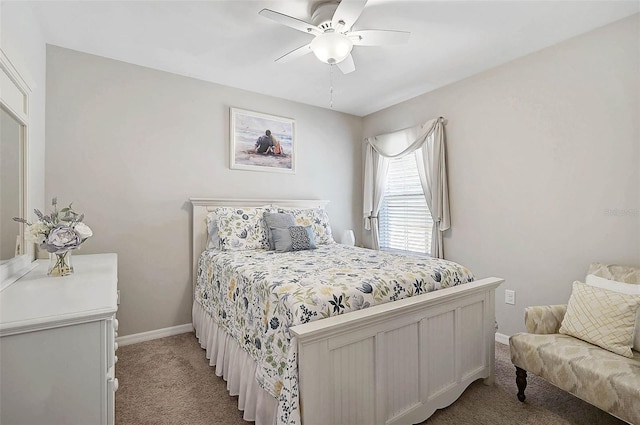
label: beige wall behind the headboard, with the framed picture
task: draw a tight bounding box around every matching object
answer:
[46,46,362,335]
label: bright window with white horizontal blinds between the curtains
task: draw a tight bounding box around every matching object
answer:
[378,154,433,254]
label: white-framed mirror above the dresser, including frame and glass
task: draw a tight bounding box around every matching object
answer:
[0,49,36,290]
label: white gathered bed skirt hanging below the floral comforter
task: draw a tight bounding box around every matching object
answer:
[192,301,278,425]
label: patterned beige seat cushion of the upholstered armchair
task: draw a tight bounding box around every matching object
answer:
[509,333,640,424]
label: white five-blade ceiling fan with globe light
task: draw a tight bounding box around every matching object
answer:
[259,0,410,74]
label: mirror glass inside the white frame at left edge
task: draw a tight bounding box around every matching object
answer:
[0,108,24,264]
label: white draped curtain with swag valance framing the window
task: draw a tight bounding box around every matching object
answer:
[363,118,451,258]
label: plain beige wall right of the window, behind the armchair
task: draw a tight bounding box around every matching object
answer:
[363,15,640,334]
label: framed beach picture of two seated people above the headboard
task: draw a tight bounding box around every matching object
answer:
[229,108,295,173]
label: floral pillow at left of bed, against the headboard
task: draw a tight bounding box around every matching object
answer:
[212,207,270,251]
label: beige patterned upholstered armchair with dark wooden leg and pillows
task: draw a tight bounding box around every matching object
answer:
[509,263,640,424]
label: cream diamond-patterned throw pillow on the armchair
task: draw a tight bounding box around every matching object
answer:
[559,281,640,357]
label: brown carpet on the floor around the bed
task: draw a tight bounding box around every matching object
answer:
[116,333,624,425]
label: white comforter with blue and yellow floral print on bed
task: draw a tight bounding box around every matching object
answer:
[195,244,473,424]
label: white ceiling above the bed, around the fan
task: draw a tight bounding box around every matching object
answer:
[18,0,640,116]
